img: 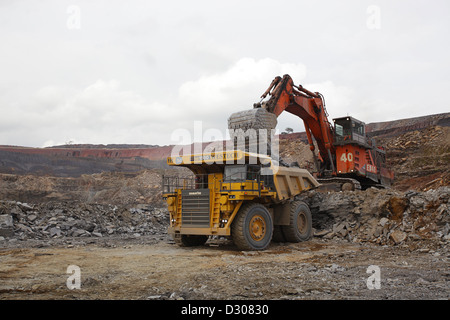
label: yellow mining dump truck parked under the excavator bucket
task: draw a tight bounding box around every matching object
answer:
[162,151,319,250]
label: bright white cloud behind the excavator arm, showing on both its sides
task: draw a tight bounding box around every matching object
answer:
[179,58,357,140]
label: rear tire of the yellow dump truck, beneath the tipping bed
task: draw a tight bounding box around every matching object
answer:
[281,201,312,242]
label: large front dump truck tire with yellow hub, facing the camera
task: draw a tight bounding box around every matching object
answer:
[231,203,273,250]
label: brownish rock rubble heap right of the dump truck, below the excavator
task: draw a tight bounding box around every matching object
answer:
[298,186,450,245]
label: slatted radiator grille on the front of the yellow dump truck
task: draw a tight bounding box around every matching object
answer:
[181,189,210,228]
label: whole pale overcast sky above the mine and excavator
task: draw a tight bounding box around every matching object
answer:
[0,0,450,147]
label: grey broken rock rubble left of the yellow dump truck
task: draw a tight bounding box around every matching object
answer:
[0,201,169,240]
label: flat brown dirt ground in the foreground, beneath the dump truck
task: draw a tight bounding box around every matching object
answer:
[0,236,450,300]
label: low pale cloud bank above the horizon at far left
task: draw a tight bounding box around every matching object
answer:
[0,79,168,146]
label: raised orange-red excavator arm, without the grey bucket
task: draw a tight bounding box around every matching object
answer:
[254,74,335,173]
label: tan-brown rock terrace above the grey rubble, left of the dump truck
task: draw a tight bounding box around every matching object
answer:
[0,168,184,206]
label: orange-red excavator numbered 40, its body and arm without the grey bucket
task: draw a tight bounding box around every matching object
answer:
[229,75,394,190]
